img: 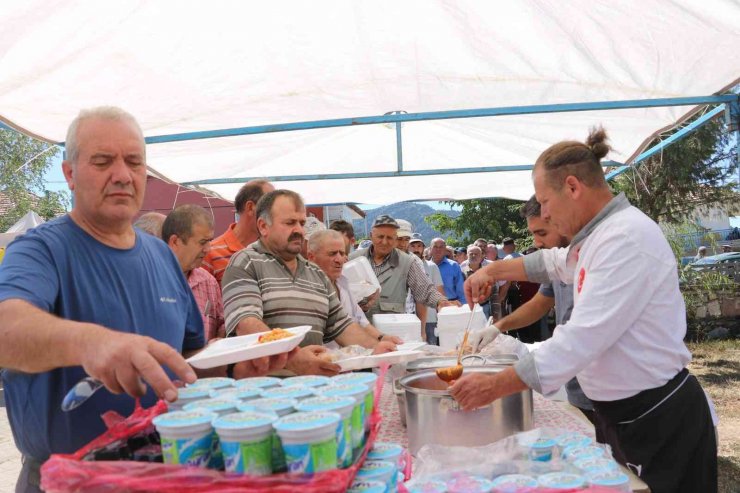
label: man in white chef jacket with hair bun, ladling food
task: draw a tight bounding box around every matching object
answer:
[451,130,717,493]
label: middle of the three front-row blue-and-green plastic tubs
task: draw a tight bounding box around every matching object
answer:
[213,412,278,476]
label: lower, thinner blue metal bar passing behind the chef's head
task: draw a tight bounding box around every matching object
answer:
[182,161,622,185]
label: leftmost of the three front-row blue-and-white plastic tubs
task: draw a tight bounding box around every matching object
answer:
[153,409,216,467]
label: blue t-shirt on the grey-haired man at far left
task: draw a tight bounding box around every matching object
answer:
[0,216,204,461]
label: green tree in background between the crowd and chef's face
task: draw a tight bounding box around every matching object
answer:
[425,198,528,246]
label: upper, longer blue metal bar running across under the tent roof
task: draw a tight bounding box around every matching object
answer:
[145,94,740,144]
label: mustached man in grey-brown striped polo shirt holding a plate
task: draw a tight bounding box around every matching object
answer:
[221,190,395,378]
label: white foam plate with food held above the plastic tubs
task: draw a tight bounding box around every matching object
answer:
[187,325,311,369]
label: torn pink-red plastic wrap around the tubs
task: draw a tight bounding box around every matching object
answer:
[41,367,387,493]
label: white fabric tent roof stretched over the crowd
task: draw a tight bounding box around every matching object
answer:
[0,0,740,204]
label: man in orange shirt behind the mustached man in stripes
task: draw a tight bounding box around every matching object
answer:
[202,180,275,283]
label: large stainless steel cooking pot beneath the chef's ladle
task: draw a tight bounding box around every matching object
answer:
[399,366,534,455]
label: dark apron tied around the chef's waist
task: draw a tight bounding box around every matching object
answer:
[593,369,717,493]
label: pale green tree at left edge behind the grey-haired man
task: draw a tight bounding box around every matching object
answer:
[0,129,69,231]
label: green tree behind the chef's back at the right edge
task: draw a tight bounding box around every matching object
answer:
[612,118,740,224]
